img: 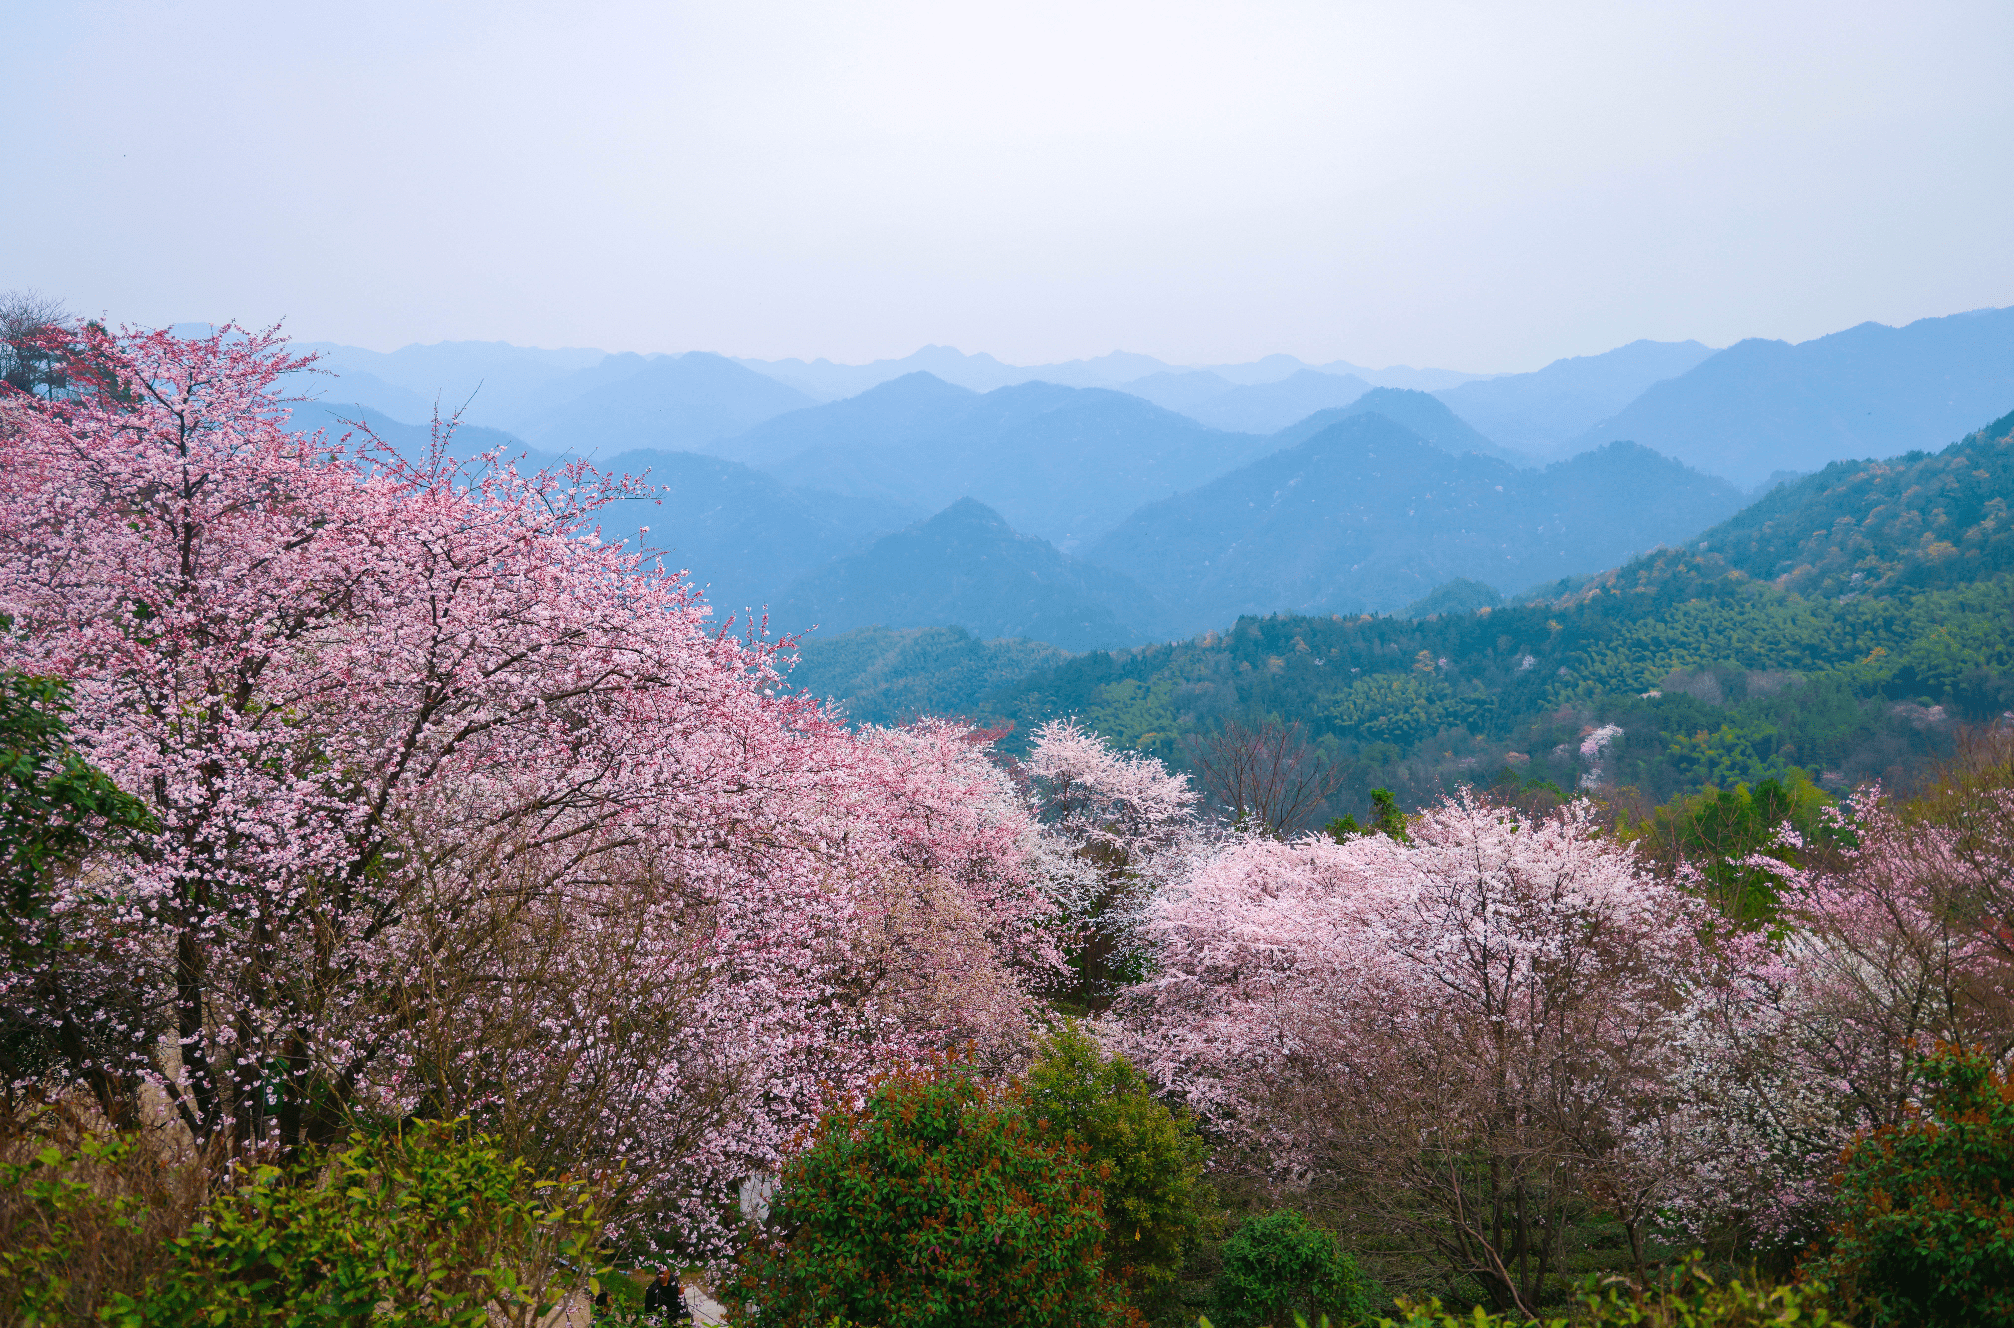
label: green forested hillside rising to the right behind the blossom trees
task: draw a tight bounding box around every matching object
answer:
[808,417,2014,810]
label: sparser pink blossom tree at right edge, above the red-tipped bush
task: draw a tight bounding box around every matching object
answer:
[1682,784,2014,1245]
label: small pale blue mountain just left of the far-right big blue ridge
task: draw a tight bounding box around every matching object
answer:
[1434,341,1714,455]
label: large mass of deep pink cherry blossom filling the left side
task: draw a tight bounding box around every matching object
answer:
[0,328,1051,1257]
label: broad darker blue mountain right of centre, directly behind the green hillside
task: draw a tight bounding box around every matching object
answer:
[1086,415,1742,633]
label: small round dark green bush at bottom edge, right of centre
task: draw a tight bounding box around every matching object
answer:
[1212,1209,1390,1328]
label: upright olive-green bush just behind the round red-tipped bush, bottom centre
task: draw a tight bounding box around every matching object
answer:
[1023,1024,1210,1292]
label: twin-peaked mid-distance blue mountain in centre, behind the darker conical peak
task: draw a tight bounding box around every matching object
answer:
[713,373,1275,548]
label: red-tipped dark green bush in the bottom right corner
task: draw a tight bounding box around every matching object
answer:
[1815,1048,2014,1328]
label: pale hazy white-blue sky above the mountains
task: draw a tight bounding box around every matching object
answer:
[0,0,2014,371]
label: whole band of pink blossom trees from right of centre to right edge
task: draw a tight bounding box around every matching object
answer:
[1104,773,2014,1249]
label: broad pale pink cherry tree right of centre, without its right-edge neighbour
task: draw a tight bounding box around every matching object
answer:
[1112,792,1704,1308]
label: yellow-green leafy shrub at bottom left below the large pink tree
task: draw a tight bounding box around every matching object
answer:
[116,1122,600,1328]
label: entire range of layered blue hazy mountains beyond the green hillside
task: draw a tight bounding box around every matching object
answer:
[294,310,2014,651]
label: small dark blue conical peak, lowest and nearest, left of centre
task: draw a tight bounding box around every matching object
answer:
[773,498,1160,651]
